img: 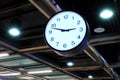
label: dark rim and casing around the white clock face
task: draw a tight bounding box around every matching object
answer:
[44,11,90,57]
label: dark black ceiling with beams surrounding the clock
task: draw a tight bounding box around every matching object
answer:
[0,0,120,80]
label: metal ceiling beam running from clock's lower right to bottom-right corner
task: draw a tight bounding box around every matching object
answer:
[84,45,120,79]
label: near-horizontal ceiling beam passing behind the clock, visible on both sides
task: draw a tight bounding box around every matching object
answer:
[19,34,120,52]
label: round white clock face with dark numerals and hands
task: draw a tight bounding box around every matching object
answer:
[45,11,86,51]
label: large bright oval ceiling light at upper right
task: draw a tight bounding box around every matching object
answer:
[100,9,114,19]
